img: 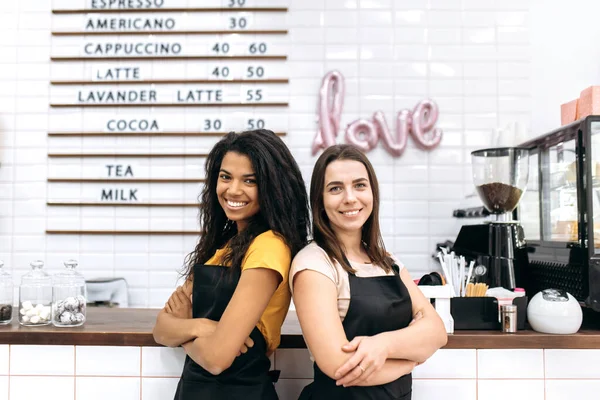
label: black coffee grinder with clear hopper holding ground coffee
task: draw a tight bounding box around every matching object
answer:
[452,147,529,289]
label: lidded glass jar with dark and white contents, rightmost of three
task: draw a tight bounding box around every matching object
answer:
[52,260,87,327]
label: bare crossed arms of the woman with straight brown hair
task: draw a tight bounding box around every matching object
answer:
[293,269,447,386]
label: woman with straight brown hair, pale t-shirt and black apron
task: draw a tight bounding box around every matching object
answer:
[290,145,447,400]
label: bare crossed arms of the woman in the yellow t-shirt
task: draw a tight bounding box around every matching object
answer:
[153,268,282,375]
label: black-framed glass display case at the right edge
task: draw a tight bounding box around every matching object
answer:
[516,116,600,311]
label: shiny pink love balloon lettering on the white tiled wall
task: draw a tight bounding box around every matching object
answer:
[312,71,442,157]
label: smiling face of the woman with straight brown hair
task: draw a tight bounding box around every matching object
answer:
[323,160,373,233]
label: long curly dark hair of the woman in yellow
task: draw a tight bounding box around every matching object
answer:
[183,129,310,278]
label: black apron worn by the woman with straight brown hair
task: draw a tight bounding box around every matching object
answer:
[299,265,412,400]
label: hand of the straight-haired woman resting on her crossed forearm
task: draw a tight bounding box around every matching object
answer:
[335,336,388,386]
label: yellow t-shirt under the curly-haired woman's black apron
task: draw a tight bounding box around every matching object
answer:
[206,231,292,353]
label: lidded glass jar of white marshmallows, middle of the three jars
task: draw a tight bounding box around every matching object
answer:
[19,260,52,326]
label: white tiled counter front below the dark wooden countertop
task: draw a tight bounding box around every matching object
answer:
[0,345,600,400]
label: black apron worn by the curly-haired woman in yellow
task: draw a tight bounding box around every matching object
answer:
[175,265,278,400]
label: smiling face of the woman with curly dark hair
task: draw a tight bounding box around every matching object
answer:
[217,151,260,231]
